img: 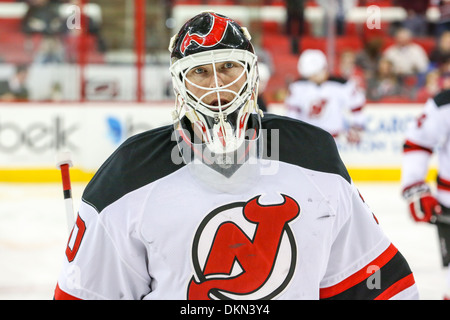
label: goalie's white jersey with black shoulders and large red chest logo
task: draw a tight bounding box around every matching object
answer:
[55,114,418,300]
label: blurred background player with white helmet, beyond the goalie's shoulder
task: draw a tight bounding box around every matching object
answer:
[285,49,366,143]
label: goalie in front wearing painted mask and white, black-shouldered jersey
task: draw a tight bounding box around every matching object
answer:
[55,12,418,300]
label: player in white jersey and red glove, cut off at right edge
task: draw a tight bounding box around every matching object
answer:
[401,90,450,299]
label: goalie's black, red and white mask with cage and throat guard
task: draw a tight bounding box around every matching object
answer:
[169,12,262,177]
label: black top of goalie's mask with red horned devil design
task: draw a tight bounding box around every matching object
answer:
[171,12,254,59]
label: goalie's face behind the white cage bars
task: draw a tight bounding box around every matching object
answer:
[185,61,247,111]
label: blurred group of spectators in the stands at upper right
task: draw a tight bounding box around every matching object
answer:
[318,0,450,102]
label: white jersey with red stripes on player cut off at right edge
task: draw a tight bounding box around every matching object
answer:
[402,90,450,208]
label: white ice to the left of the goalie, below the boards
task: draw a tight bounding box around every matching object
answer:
[0,184,84,299]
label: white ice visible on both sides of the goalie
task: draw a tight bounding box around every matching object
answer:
[0,182,445,300]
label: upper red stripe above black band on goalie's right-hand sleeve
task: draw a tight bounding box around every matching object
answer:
[320,244,398,299]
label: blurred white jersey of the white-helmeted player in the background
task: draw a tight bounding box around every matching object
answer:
[285,77,366,136]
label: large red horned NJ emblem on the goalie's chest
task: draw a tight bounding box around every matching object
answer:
[188,195,300,300]
